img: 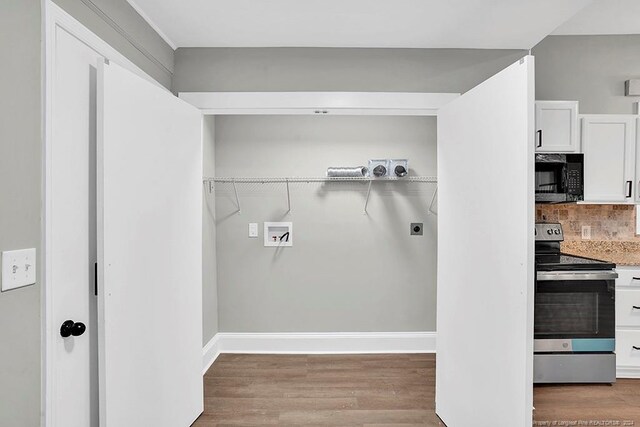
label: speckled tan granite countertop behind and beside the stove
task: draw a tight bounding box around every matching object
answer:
[561,240,640,265]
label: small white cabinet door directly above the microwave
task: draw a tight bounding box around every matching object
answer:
[536,101,580,153]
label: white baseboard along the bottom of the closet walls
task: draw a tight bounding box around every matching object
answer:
[203,332,436,372]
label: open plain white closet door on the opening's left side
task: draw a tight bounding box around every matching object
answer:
[97,62,203,427]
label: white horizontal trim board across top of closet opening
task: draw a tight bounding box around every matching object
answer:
[178,92,460,116]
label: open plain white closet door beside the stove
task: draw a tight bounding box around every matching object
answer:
[436,56,535,427]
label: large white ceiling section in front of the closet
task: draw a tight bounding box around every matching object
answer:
[128,0,592,49]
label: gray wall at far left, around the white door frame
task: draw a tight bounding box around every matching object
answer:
[0,0,173,427]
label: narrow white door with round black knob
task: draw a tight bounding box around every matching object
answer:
[45,20,102,427]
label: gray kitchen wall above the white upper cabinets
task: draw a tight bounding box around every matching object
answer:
[533,35,640,114]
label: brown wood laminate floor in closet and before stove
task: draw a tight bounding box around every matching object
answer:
[194,354,640,427]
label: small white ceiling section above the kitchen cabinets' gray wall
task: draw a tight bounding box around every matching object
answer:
[552,0,640,35]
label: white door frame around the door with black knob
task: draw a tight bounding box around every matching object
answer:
[39,0,166,427]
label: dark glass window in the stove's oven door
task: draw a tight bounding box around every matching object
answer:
[534,293,599,335]
